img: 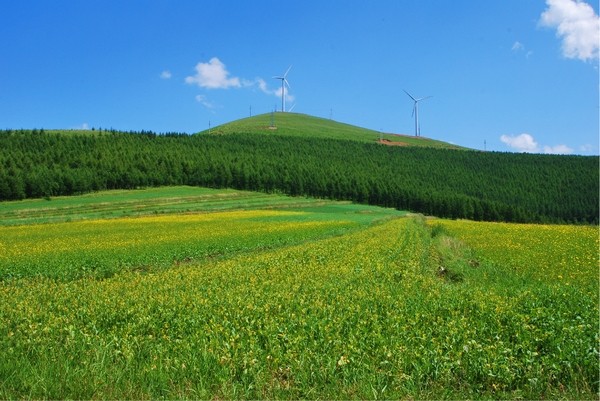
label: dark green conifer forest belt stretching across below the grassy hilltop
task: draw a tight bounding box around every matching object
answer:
[0,130,599,224]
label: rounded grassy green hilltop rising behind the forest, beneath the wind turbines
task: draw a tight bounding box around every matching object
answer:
[201,113,465,149]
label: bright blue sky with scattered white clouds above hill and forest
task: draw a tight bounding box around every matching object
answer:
[0,0,600,155]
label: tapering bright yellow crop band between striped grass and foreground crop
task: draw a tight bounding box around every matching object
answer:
[0,210,366,280]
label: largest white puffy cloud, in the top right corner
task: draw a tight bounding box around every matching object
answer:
[540,0,600,61]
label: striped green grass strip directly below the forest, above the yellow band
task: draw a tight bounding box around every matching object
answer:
[0,186,384,226]
